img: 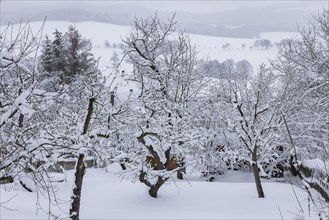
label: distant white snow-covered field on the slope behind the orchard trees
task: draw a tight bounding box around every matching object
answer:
[1,21,297,69]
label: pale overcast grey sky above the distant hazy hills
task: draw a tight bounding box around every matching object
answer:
[0,0,329,13]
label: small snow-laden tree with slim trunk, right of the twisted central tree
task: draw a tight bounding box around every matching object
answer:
[216,66,280,198]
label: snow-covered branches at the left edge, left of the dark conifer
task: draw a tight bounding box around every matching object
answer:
[0,21,68,212]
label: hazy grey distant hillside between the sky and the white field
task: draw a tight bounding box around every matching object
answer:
[0,1,322,38]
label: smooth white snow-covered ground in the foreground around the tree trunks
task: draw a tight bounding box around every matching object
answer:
[0,165,307,219]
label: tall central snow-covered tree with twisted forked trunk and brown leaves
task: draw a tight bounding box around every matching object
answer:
[119,13,204,197]
